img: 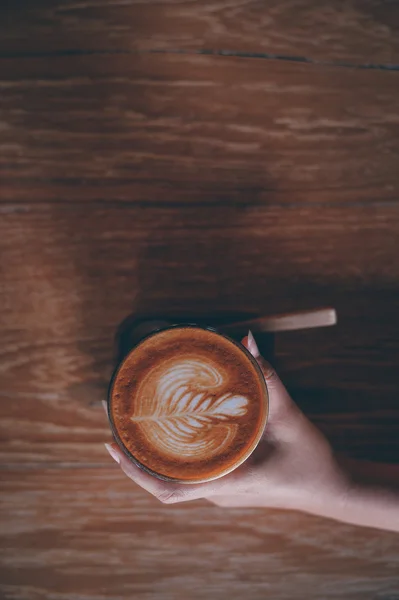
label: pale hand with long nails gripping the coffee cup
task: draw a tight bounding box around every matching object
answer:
[106,333,346,513]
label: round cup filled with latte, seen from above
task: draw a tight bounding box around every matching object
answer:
[108,324,269,484]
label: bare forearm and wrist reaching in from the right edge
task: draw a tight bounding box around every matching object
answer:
[313,460,399,532]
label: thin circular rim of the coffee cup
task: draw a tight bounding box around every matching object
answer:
[107,323,270,485]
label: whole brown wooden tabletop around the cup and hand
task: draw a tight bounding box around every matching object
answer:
[0,0,399,600]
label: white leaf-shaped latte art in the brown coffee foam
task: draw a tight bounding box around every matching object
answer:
[131,358,248,461]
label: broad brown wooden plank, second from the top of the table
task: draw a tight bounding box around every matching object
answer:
[0,55,399,206]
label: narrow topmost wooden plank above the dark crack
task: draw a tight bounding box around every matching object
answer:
[0,0,399,65]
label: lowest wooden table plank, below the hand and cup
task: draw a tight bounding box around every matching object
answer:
[0,468,399,600]
